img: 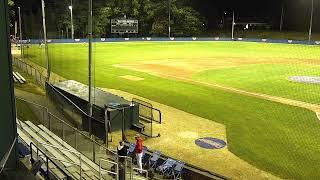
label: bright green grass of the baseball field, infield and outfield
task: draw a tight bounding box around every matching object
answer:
[25,42,320,179]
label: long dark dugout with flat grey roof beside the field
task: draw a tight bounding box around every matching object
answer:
[47,80,139,141]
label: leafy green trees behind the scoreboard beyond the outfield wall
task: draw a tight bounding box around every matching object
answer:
[47,0,206,37]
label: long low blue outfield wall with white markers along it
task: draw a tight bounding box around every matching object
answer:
[23,37,320,45]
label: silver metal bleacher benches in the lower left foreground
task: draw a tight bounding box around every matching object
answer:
[17,121,113,179]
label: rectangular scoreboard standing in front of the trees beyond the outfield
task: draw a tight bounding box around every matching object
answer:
[111,19,138,34]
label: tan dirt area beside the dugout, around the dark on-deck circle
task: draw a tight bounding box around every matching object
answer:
[102,88,278,179]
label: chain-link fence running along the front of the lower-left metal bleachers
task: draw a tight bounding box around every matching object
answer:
[16,98,117,167]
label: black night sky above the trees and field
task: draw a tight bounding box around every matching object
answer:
[18,0,320,32]
